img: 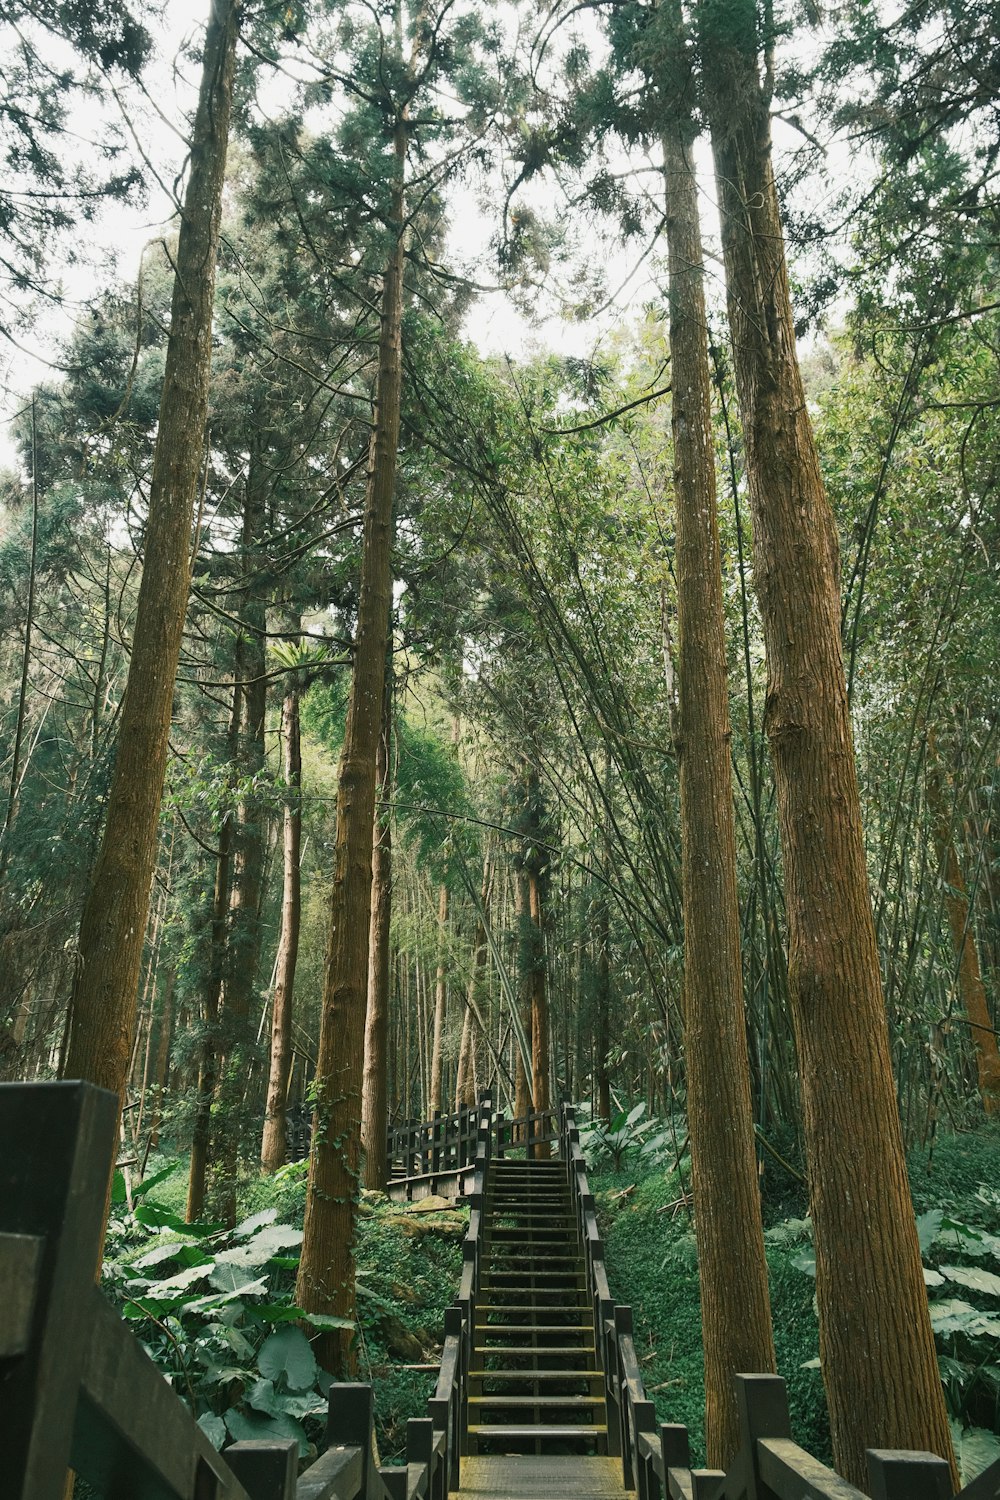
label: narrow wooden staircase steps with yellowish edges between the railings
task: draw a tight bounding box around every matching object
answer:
[468,1160,607,1455]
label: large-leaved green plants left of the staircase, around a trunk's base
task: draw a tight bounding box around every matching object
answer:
[103,1161,460,1457]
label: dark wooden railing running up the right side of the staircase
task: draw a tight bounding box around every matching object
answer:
[559,1106,1000,1500]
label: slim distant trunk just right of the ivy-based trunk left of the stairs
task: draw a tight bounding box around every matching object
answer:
[361,675,393,1193]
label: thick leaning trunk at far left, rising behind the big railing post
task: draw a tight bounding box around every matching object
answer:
[66,0,238,1128]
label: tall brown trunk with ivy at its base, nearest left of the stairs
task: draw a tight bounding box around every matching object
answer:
[295,120,406,1377]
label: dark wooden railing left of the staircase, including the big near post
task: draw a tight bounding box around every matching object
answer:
[0,1083,492,1500]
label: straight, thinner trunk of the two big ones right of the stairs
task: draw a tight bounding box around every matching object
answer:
[663,49,775,1469]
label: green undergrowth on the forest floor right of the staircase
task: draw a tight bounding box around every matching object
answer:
[591,1124,1000,1481]
